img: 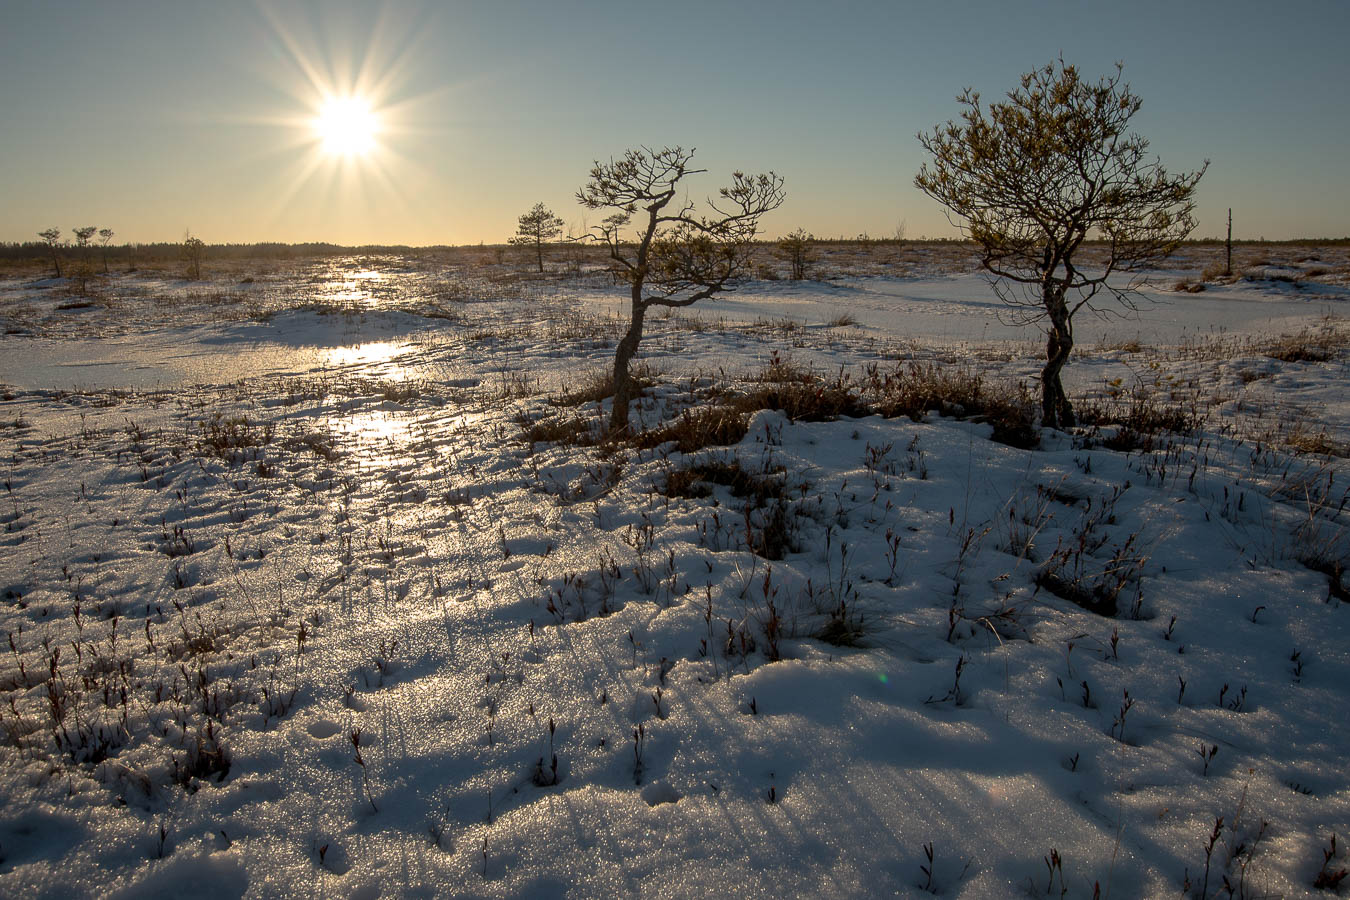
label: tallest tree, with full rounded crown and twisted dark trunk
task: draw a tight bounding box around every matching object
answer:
[914,59,1208,428]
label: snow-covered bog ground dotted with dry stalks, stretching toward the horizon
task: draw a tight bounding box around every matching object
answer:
[0,252,1350,897]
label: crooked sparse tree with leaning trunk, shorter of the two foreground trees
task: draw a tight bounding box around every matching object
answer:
[576,147,786,430]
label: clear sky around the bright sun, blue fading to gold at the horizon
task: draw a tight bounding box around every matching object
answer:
[0,0,1350,244]
